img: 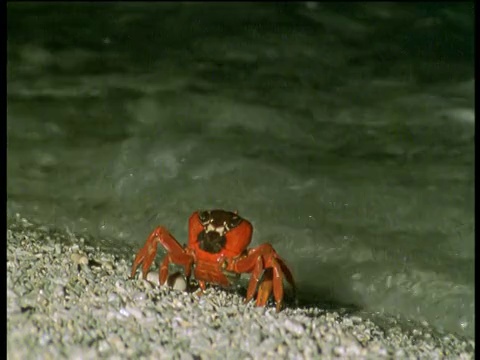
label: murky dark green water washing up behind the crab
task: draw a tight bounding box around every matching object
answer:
[7,2,475,336]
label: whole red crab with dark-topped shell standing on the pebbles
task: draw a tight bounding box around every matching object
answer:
[130,210,295,311]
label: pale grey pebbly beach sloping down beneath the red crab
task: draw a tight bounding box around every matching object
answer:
[7,216,475,359]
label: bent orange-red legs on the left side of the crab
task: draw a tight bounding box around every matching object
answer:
[130,226,193,285]
